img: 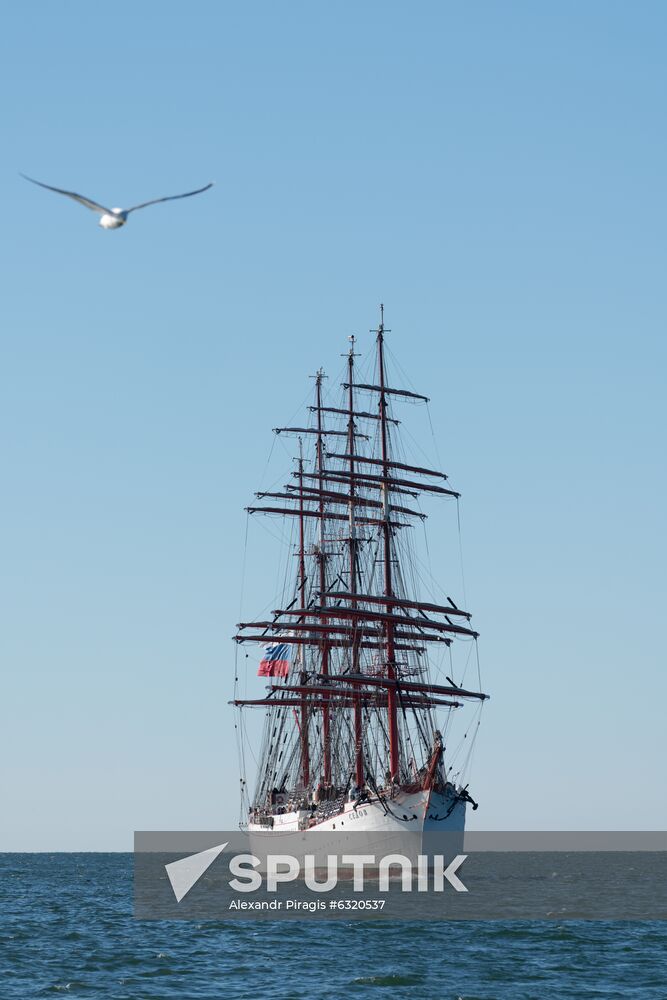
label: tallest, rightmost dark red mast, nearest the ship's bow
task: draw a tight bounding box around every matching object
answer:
[378,305,400,781]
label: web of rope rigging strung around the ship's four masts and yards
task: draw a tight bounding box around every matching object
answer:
[234,325,485,819]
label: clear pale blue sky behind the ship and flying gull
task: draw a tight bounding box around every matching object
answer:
[0,0,667,850]
